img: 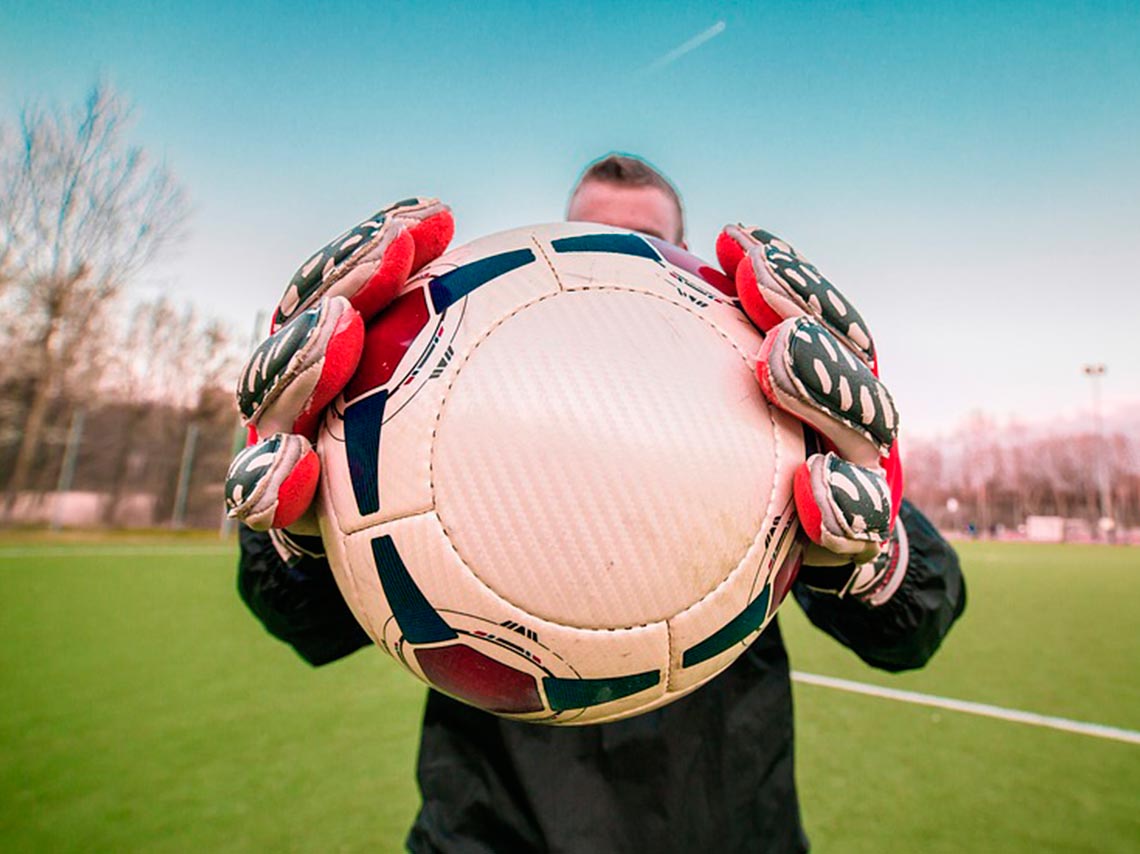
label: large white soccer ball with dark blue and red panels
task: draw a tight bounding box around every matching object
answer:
[318,223,804,724]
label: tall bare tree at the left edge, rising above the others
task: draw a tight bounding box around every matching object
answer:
[0,86,187,503]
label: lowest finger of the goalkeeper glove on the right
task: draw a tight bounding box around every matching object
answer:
[795,453,891,563]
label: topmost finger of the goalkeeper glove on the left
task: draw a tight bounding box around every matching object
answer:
[272,198,455,330]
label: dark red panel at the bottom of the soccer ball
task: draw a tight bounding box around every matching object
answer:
[415,643,544,715]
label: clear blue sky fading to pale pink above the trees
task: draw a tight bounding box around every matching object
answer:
[0,0,1140,433]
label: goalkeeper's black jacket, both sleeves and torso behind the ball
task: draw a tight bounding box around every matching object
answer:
[238,502,966,854]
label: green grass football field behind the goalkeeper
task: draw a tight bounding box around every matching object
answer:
[0,536,1140,852]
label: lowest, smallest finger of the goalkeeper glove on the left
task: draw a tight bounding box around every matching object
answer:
[226,433,320,531]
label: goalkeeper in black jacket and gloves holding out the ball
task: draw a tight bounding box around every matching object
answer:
[226,154,966,853]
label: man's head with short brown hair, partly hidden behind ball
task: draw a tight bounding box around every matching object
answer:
[567,154,685,246]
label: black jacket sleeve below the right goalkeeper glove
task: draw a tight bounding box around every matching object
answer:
[792,501,966,672]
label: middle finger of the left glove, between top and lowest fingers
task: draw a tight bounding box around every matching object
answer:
[237,296,364,439]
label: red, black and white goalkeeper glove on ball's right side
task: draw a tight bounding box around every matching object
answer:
[716,225,906,604]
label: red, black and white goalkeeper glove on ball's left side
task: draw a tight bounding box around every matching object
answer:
[226,198,455,534]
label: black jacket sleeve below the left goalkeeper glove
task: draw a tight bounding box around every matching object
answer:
[237,524,372,666]
